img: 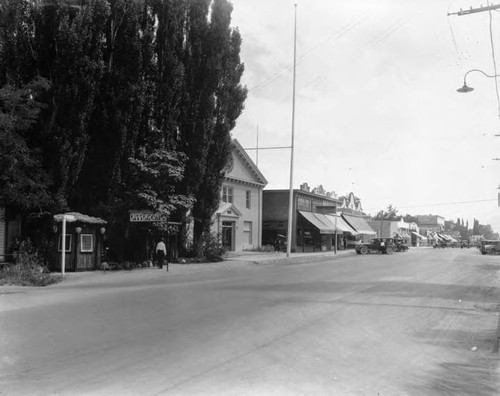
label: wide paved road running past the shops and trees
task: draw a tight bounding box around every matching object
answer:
[0,249,500,396]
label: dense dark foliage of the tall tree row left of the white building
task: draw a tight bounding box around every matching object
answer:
[0,0,246,255]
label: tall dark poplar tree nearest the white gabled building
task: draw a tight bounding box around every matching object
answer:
[180,0,247,251]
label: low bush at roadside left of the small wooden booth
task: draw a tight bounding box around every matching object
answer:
[0,240,61,286]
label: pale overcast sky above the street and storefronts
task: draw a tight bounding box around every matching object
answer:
[232,0,500,231]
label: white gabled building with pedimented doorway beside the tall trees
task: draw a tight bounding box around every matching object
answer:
[212,139,267,251]
